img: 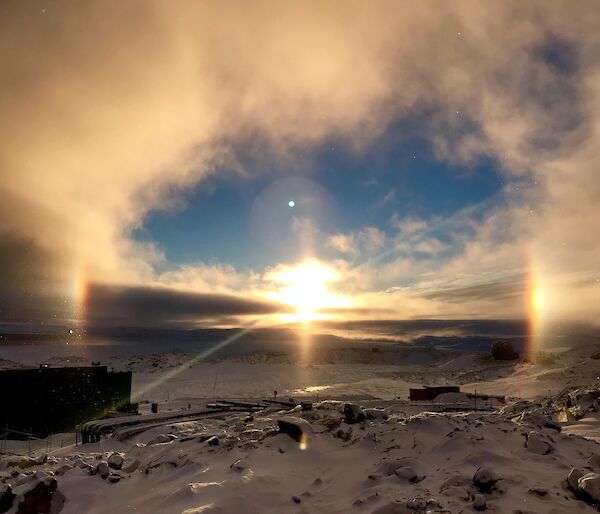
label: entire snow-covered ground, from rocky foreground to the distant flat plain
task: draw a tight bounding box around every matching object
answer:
[0,338,600,514]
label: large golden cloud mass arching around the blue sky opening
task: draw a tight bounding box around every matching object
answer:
[0,0,600,324]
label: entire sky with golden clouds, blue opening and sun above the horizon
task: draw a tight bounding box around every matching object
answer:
[0,0,600,330]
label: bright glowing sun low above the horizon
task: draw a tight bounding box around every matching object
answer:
[267,259,348,323]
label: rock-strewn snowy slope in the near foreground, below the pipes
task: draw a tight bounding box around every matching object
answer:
[0,401,600,514]
